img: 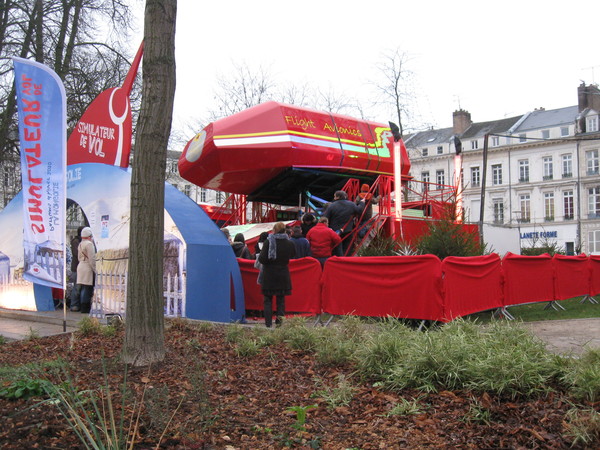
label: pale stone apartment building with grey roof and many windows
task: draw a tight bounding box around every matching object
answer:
[405,83,600,254]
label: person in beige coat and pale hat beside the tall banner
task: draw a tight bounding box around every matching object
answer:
[71,227,96,314]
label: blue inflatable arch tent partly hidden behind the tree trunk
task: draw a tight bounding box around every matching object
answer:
[0,163,245,323]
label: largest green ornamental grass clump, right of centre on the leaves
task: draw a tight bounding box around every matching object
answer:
[357,320,561,398]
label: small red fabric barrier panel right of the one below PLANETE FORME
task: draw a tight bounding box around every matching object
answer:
[553,255,590,300]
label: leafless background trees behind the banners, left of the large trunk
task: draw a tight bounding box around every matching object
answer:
[0,0,137,203]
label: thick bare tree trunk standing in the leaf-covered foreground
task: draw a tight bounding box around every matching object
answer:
[123,0,177,366]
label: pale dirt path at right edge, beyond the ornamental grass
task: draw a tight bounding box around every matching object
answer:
[523,318,600,355]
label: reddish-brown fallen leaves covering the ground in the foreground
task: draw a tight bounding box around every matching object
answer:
[0,326,570,450]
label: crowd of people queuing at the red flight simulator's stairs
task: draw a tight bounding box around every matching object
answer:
[223,184,379,328]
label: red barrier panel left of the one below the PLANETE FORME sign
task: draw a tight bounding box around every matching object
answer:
[442,253,503,321]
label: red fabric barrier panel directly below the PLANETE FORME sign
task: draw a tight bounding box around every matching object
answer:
[502,252,554,306]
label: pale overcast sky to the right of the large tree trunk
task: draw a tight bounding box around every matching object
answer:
[135,0,600,137]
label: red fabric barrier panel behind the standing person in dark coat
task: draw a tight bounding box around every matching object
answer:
[238,258,322,315]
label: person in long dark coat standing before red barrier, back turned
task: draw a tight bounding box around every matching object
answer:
[258,222,296,328]
